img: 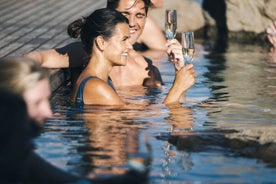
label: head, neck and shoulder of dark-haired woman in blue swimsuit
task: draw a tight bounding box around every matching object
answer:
[72,9,132,105]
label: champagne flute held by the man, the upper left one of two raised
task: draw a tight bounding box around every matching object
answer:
[165,10,177,39]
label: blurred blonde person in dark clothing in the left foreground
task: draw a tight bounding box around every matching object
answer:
[0,57,148,184]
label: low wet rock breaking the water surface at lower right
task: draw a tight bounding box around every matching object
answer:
[168,127,276,167]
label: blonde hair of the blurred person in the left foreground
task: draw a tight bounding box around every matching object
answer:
[0,57,50,96]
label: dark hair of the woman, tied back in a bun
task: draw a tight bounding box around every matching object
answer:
[67,8,128,54]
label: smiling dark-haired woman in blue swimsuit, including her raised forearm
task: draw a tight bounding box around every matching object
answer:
[70,7,195,106]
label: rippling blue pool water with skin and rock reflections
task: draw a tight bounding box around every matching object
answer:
[36,40,276,183]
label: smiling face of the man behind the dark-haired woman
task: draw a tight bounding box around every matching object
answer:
[116,0,146,44]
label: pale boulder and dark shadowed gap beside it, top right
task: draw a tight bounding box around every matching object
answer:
[201,0,276,43]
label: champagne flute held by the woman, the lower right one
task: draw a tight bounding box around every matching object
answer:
[181,32,195,65]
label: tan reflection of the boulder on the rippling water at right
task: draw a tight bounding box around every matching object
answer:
[202,42,276,126]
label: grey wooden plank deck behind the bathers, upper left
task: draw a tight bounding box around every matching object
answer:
[0,0,106,90]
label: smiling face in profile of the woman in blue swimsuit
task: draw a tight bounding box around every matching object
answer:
[105,23,132,66]
